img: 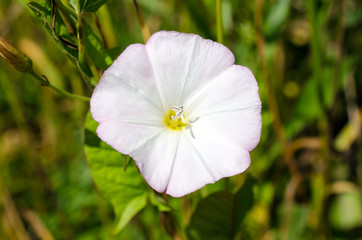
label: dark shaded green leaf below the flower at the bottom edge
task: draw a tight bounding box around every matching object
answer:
[188,176,254,240]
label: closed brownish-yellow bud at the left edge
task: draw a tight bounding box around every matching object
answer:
[0,37,33,72]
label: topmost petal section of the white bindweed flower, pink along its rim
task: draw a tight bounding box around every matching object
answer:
[146,31,235,107]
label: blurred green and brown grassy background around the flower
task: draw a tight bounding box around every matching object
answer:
[0,0,362,240]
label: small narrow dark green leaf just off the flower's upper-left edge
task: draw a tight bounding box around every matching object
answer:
[83,22,113,71]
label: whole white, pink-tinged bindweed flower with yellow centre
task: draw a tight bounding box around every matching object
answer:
[90,31,261,197]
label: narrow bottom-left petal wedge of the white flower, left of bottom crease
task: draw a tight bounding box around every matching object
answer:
[130,129,180,192]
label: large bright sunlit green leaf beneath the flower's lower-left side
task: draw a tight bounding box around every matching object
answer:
[85,114,149,232]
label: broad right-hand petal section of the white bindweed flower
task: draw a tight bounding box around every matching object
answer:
[185,65,262,151]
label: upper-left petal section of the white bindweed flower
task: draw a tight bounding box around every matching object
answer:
[90,44,163,123]
